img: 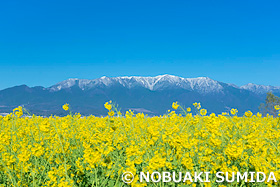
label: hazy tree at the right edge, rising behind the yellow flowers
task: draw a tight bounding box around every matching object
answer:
[259,92,280,116]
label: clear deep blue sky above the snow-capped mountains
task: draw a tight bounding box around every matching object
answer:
[0,0,280,89]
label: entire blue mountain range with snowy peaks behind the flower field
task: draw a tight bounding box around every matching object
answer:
[0,75,280,116]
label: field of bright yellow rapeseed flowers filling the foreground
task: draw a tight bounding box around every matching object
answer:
[0,102,280,187]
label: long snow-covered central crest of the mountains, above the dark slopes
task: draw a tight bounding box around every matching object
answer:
[49,75,223,93]
